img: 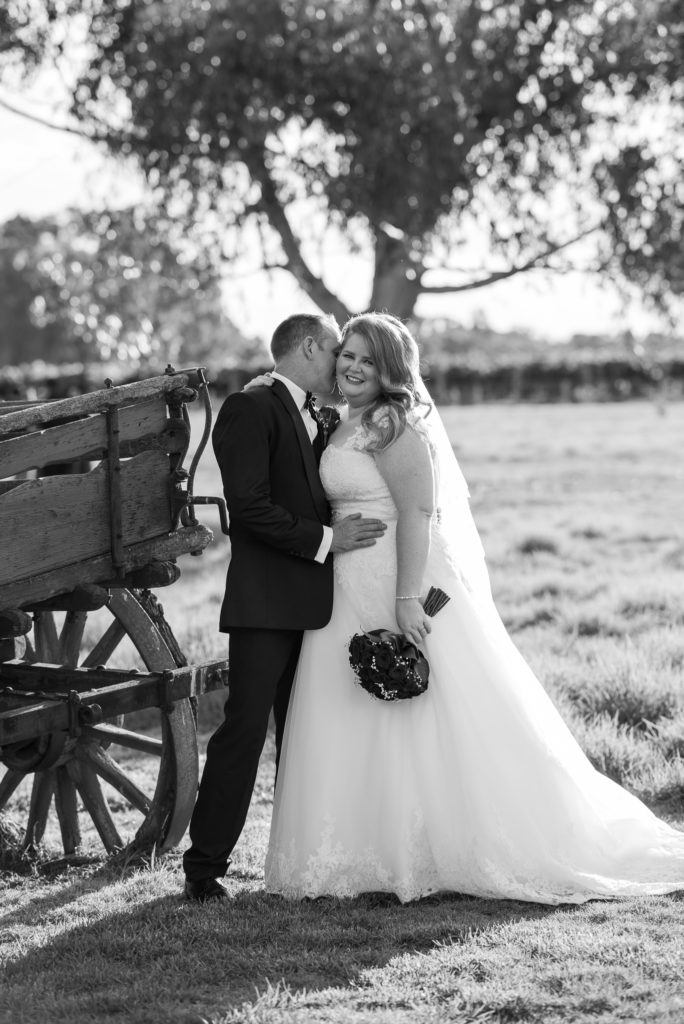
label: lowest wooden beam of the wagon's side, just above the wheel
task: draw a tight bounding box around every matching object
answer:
[0,524,213,608]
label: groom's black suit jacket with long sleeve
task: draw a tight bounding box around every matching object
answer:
[212,381,333,632]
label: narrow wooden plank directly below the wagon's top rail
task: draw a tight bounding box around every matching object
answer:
[0,395,168,477]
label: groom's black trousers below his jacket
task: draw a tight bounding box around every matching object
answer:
[183,629,303,882]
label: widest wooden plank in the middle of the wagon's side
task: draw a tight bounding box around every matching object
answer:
[0,452,171,586]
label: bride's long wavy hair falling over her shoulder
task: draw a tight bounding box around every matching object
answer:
[342,313,430,452]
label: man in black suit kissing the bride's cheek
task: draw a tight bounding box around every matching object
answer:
[183,314,385,903]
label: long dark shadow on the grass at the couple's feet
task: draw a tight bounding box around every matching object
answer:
[0,867,575,1024]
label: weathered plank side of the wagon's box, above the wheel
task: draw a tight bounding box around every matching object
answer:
[0,368,227,609]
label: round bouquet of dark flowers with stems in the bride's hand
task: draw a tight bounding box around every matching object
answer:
[349,587,450,700]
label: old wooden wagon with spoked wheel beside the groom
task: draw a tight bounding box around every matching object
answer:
[0,368,227,855]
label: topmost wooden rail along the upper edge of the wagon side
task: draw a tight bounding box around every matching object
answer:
[0,374,189,437]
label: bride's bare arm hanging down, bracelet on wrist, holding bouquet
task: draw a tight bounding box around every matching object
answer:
[375,427,434,643]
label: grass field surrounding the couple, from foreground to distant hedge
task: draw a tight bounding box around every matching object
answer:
[0,403,684,1024]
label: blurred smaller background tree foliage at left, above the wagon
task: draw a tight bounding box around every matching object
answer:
[0,209,243,371]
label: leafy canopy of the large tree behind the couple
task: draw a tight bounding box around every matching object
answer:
[5,0,684,317]
